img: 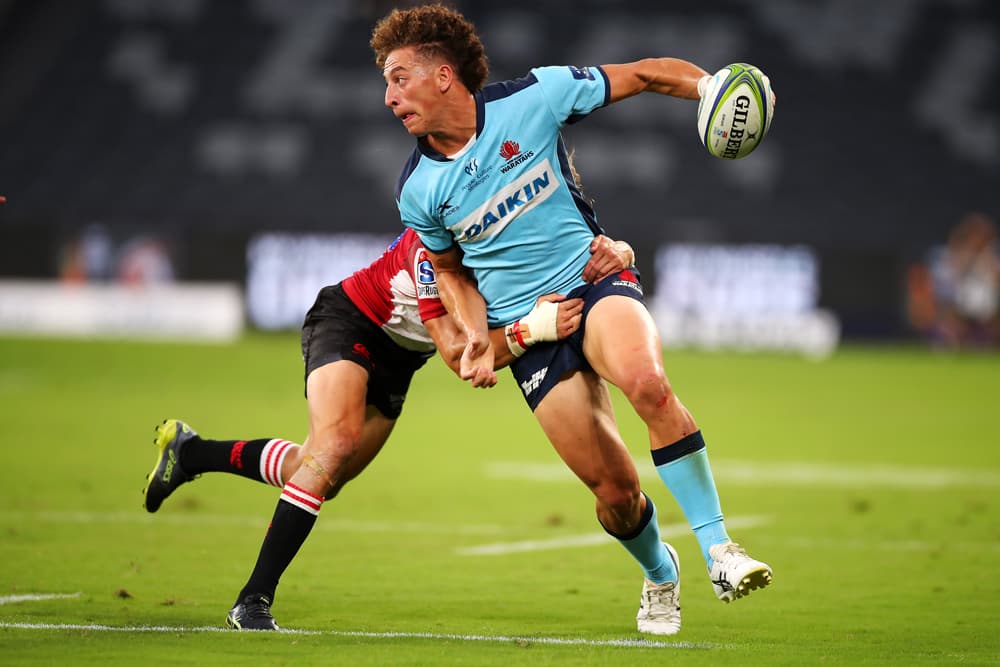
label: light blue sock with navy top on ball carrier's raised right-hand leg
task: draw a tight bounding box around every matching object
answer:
[652,431,729,567]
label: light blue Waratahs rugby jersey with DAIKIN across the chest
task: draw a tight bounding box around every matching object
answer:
[396,66,609,327]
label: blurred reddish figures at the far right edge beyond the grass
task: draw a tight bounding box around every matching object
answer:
[906,213,1000,348]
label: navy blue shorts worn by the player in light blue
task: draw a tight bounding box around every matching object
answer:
[510,268,644,412]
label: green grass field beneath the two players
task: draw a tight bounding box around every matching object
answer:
[0,334,1000,666]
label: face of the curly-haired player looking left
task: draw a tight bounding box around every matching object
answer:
[382,47,441,137]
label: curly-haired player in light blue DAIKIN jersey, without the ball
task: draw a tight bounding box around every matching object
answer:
[371,5,771,634]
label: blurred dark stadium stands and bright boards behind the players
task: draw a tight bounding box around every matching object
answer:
[0,0,1000,353]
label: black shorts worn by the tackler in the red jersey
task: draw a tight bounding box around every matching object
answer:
[302,283,434,419]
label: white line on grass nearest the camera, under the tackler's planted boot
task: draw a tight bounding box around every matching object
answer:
[0,621,720,649]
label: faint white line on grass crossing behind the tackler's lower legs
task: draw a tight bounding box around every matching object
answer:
[0,510,505,535]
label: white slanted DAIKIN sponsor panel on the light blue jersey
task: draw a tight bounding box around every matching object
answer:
[448,160,556,243]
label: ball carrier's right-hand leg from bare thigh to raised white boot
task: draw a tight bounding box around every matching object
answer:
[584,295,771,602]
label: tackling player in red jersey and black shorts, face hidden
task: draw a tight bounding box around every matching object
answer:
[143,229,634,630]
